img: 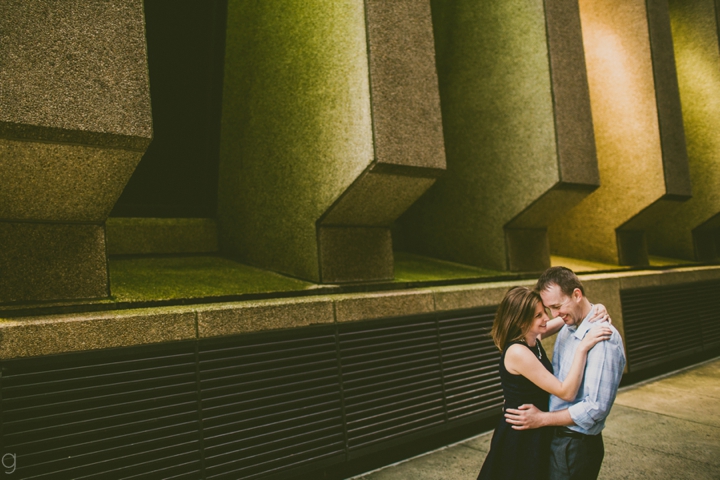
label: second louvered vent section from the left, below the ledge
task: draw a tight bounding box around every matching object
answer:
[200,328,345,479]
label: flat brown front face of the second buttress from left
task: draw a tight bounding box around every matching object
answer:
[365,0,445,171]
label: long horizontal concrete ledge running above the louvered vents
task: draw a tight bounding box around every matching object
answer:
[0,266,720,360]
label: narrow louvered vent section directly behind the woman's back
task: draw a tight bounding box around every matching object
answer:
[440,308,503,420]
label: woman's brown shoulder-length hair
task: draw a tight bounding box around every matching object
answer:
[491,287,542,352]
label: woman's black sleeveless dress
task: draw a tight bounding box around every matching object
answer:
[478,341,553,480]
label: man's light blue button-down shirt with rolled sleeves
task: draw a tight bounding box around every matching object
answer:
[550,308,625,435]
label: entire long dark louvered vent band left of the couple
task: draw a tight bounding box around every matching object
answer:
[0,309,502,480]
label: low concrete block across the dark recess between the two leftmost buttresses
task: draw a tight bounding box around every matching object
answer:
[105,218,218,255]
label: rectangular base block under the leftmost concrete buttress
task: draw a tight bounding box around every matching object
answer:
[0,222,109,303]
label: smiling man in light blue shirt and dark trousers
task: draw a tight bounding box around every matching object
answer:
[505,267,625,480]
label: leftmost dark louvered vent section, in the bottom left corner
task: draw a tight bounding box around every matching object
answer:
[2,342,201,479]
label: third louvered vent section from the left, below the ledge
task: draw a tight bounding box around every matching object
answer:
[339,317,445,450]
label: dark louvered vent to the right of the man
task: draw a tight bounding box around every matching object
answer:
[620,281,720,372]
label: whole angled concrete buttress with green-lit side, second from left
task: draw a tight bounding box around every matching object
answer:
[218,0,445,283]
